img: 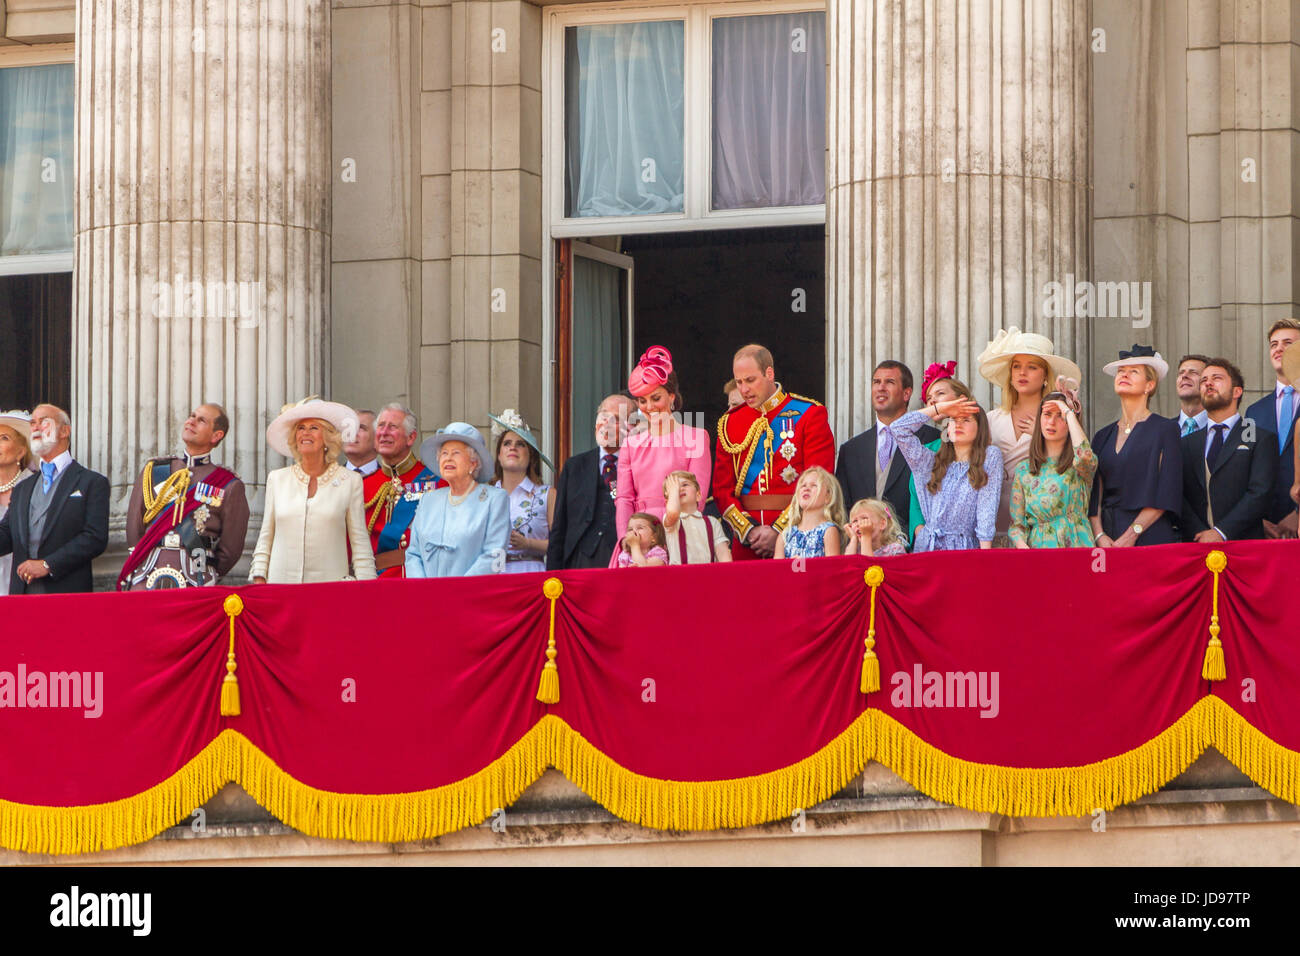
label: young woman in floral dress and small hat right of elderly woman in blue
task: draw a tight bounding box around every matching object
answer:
[488,408,555,574]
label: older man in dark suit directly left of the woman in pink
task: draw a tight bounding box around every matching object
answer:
[546,395,636,571]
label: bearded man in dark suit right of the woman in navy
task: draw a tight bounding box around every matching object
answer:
[1182,359,1278,544]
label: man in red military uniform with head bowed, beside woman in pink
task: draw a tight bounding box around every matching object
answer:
[714,345,835,561]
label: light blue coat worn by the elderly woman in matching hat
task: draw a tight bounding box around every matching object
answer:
[406,484,510,578]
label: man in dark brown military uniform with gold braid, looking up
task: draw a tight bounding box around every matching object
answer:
[117,402,248,591]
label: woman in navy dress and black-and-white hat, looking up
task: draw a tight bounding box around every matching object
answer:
[1088,345,1183,548]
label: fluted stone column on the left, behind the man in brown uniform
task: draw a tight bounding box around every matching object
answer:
[73,0,330,529]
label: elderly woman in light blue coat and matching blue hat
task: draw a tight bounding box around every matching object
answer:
[406,421,510,578]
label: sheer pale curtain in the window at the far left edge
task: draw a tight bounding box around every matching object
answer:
[0,64,74,255]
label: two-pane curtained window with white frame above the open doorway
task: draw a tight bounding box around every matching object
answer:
[543,3,826,237]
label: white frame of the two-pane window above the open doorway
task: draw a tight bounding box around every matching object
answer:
[542,0,826,239]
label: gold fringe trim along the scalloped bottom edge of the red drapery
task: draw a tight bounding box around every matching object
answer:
[0,696,1300,853]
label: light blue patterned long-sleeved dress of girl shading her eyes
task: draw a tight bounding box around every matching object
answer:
[888,411,1002,551]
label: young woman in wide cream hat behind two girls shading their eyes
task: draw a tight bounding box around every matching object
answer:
[975,325,1083,545]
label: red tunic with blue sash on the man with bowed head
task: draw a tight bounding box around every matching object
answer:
[714,389,835,559]
